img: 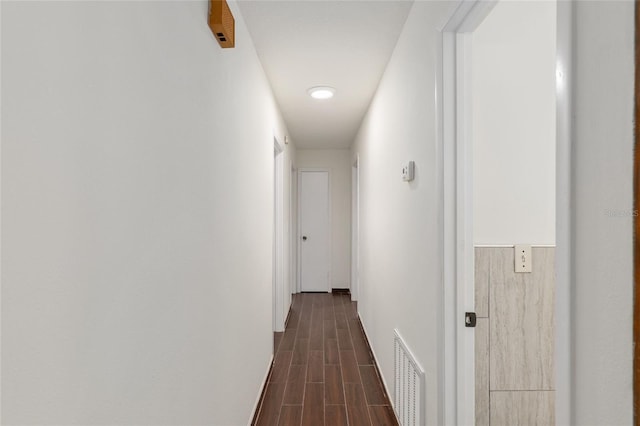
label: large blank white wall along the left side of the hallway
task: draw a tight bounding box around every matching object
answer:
[2,1,292,425]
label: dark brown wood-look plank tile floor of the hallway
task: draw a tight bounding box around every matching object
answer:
[254,293,398,426]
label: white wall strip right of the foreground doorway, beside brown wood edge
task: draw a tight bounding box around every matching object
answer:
[572,1,634,425]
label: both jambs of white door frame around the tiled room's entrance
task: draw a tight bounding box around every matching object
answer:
[437,0,574,425]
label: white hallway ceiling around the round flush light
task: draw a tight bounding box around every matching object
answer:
[239,0,412,149]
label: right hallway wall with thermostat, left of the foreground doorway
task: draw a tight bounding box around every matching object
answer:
[352,2,456,425]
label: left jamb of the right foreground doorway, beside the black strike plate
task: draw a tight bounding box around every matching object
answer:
[437,0,497,425]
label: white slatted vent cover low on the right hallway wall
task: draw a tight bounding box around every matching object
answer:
[393,329,426,426]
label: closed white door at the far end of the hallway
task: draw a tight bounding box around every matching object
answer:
[299,171,331,291]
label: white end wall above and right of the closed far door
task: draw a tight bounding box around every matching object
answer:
[296,149,352,288]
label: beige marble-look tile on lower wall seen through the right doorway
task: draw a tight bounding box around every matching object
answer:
[475,247,555,426]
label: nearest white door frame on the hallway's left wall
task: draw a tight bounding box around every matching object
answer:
[272,136,286,332]
